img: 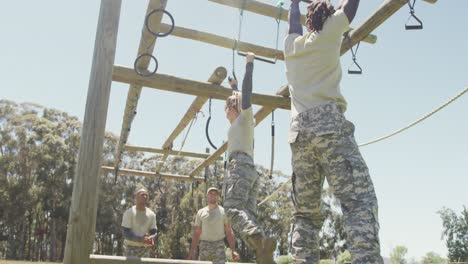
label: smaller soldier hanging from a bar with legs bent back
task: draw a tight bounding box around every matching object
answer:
[224,53,276,264]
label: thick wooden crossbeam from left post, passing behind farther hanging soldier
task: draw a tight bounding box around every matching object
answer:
[113,66,291,110]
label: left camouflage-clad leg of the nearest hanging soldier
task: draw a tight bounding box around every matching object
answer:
[291,133,324,263]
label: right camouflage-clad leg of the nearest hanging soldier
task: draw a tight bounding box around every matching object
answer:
[318,121,383,264]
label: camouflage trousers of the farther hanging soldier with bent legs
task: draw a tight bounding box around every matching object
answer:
[223,152,263,241]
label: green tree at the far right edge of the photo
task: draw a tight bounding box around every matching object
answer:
[438,206,468,262]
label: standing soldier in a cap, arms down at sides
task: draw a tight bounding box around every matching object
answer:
[187,187,239,264]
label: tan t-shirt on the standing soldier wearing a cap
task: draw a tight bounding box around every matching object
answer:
[194,205,229,241]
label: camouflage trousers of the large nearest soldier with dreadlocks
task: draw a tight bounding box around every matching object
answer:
[289,103,383,264]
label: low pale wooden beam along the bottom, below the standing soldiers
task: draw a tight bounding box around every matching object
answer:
[89,255,246,264]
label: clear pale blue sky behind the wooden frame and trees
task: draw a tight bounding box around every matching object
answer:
[0,0,468,258]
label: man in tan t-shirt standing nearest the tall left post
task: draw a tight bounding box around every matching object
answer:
[122,185,156,258]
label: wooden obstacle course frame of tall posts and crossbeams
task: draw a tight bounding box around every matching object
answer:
[64,0,436,264]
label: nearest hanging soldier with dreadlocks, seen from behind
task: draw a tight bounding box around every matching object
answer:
[284,0,383,264]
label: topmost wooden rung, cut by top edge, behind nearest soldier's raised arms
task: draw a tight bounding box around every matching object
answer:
[209,0,377,44]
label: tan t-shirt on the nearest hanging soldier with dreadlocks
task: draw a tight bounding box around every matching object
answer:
[284,10,349,117]
